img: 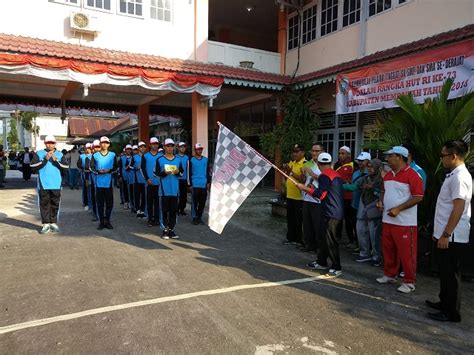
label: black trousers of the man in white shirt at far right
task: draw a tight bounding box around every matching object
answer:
[436,243,467,320]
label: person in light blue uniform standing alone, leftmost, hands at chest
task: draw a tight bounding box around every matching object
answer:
[30,135,69,234]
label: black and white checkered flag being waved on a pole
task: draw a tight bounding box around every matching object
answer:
[209,124,272,234]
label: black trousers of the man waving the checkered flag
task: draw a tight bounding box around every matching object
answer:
[317,217,342,270]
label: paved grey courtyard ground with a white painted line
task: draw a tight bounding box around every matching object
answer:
[0,171,474,354]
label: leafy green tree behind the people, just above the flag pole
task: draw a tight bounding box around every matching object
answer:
[260,89,319,164]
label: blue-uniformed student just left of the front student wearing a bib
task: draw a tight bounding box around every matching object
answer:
[141,137,163,227]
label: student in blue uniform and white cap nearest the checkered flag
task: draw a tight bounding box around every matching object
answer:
[188,143,210,225]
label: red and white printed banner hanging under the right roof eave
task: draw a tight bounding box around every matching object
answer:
[336,40,474,115]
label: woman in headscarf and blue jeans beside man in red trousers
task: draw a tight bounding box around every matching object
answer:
[356,159,383,266]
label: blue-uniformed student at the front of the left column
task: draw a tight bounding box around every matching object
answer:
[90,136,118,230]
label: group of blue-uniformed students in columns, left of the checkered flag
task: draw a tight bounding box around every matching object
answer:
[77,137,210,239]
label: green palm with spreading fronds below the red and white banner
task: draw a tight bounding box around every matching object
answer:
[367,79,474,233]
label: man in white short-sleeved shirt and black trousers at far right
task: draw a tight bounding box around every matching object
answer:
[426,140,472,322]
